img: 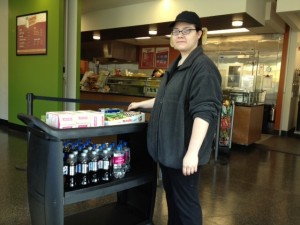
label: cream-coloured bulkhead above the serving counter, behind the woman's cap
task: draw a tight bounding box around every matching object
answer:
[81,0,265,31]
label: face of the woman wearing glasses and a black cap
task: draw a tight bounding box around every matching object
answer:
[172,22,202,54]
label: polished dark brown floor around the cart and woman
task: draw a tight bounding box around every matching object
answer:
[0,125,300,225]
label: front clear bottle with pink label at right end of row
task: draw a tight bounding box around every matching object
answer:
[113,145,125,179]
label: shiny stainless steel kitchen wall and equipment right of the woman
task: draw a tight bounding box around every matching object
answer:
[203,34,283,104]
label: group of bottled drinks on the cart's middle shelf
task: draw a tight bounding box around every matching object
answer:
[63,139,130,191]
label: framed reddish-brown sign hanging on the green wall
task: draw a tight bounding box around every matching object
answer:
[16,11,47,55]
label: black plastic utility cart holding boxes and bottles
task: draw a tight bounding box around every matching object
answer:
[18,95,157,225]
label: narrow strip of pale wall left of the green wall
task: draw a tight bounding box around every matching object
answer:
[0,0,8,120]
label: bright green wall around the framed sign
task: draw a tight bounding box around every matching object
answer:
[8,0,74,125]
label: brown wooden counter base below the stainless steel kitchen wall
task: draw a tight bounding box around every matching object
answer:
[232,105,264,145]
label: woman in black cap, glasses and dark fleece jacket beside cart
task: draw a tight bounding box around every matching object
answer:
[128,11,222,225]
